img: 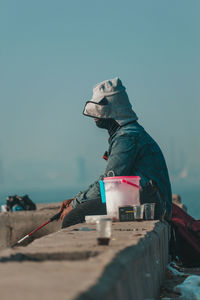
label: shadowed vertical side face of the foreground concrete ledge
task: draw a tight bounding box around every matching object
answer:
[76,220,168,300]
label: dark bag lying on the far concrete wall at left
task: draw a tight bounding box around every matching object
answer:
[6,195,36,211]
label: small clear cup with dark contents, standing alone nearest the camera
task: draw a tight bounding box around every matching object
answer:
[96,218,112,245]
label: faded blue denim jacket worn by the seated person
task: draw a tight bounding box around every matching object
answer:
[72,122,172,220]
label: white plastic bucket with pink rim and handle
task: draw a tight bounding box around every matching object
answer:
[99,176,140,219]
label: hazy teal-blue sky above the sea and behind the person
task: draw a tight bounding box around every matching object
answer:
[0,0,200,190]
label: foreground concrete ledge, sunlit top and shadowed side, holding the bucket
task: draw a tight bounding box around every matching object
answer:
[0,221,169,300]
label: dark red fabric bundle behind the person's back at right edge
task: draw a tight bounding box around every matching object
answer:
[170,204,200,267]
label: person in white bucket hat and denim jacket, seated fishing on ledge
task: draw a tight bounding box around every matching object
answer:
[60,78,172,228]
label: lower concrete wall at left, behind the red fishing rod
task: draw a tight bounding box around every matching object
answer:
[0,203,61,249]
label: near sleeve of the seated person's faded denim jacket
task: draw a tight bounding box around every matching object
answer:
[72,136,136,207]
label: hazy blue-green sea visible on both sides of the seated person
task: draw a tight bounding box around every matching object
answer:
[0,185,200,219]
